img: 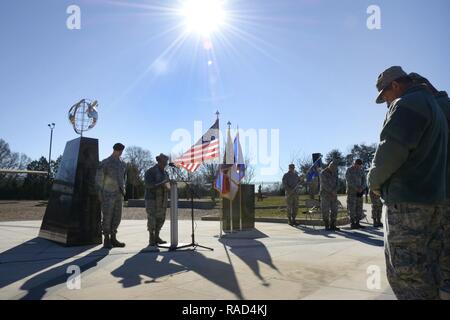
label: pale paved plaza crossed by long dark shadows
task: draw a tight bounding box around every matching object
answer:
[0,211,395,300]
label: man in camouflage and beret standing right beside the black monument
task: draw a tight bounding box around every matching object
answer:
[96,143,127,249]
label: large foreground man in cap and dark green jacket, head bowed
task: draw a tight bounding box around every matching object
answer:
[368,67,448,299]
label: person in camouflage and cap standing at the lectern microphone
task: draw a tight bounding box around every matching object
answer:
[145,153,170,246]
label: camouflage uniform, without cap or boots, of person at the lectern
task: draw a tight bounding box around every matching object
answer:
[145,164,169,237]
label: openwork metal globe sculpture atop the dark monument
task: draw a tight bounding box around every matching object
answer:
[69,99,98,136]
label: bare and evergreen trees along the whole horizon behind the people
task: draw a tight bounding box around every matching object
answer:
[0,139,377,201]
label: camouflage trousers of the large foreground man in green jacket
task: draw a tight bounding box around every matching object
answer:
[385,204,442,300]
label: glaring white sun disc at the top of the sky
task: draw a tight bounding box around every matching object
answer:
[180,0,226,37]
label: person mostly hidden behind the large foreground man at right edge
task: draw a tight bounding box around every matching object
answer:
[409,73,450,300]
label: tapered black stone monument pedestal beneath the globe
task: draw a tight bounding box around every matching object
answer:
[39,137,102,246]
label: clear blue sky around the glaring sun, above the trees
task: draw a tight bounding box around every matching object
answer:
[0,0,450,181]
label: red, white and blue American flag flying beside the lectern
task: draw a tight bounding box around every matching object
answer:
[174,119,220,172]
